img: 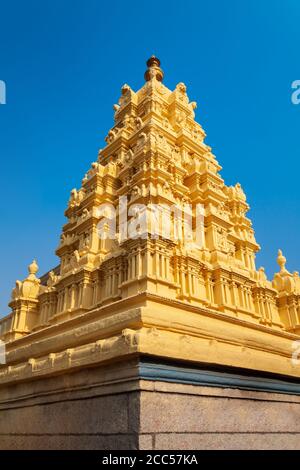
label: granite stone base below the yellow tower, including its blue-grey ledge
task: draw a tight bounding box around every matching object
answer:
[0,358,300,450]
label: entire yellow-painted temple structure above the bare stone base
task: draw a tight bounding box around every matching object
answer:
[0,57,300,383]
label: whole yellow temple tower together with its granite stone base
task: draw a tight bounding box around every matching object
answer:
[0,56,300,449]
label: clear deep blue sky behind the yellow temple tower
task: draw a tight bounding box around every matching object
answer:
[0,0,300,314]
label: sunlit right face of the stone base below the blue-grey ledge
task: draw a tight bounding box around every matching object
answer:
[139,382,300,450]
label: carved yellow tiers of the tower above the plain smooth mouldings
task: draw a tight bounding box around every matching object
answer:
[0,58,300,378]
